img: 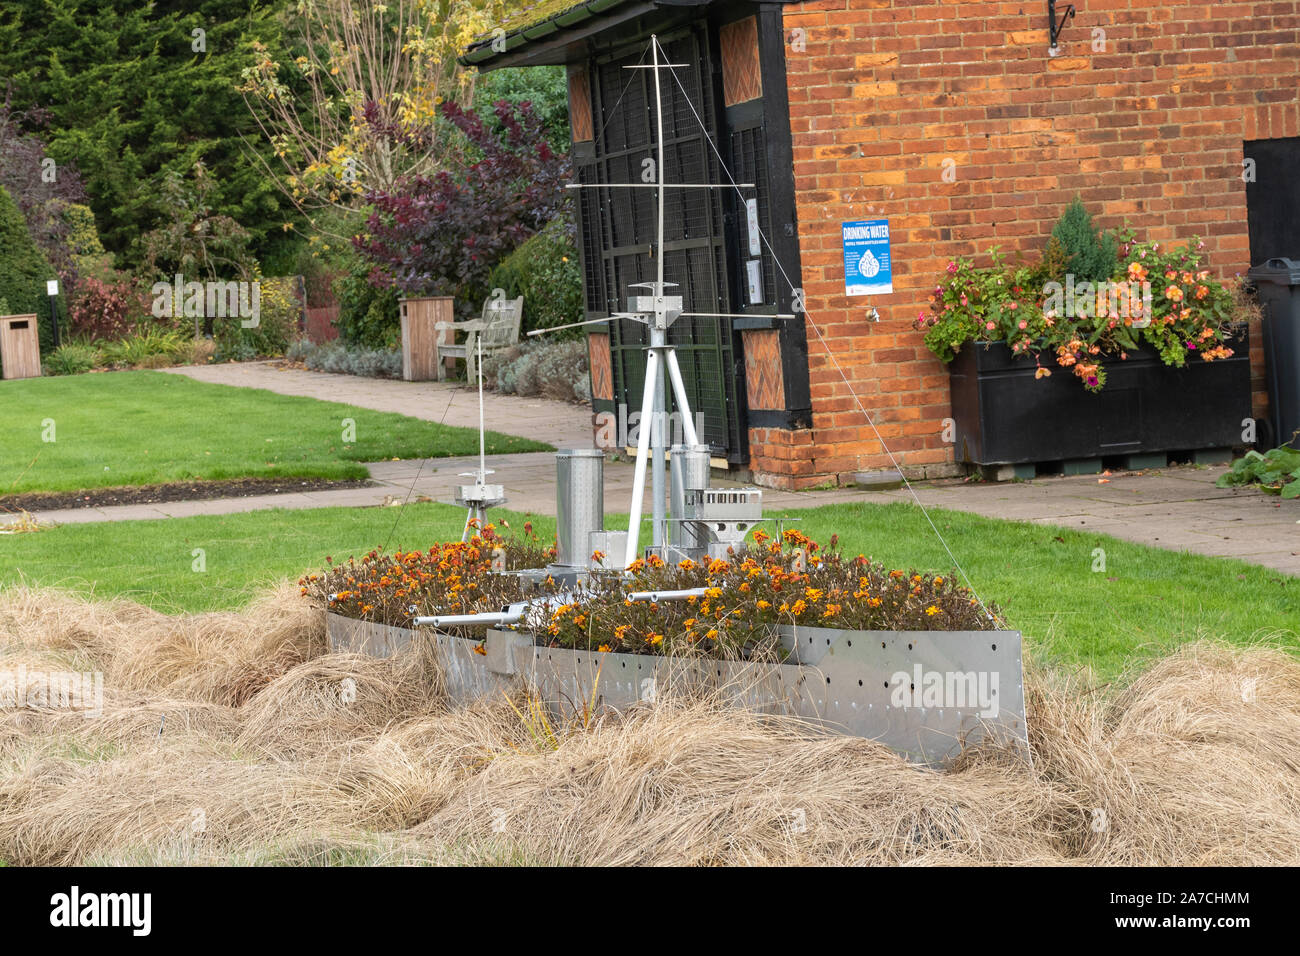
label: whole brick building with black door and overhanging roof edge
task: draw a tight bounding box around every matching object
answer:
[464,0,1300,488]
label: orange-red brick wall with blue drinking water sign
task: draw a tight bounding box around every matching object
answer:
[769,0,1300,486]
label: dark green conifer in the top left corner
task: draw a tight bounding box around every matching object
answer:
[0,0,294,265]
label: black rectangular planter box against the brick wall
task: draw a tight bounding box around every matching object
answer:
[948,325,1251,464]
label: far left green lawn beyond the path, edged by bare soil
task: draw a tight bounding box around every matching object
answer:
[0,372,551,494]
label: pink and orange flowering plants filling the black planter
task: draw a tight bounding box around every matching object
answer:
[915,218,1251,392]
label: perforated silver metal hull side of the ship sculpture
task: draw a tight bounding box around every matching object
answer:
[317,615,1030,765]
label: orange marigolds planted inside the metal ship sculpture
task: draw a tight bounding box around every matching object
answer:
[300,524,1004,659]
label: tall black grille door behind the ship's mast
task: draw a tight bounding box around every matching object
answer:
[579,25,748,462]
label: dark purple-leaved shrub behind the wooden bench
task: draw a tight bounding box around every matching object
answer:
[354,101,569,312]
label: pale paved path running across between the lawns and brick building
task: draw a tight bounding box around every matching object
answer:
[5,363,1300,575]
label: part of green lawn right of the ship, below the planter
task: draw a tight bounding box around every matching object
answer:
[790,503,1300,678]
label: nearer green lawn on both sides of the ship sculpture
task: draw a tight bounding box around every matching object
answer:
[0,503,1300,679]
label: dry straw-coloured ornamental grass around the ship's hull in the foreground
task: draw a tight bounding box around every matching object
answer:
[0,588,1300,865]
